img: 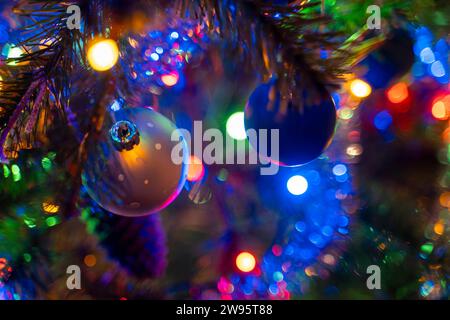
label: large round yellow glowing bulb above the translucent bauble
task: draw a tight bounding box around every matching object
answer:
[87,39,119,71]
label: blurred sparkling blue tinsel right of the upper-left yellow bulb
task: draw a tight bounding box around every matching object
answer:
[124,21,205,94]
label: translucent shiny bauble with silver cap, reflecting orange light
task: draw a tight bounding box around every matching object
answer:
[82,108,188,217]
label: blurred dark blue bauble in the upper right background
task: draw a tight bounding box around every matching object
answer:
[360,29,414,89]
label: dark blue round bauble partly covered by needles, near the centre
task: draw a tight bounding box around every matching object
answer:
[245,80,336,166]
